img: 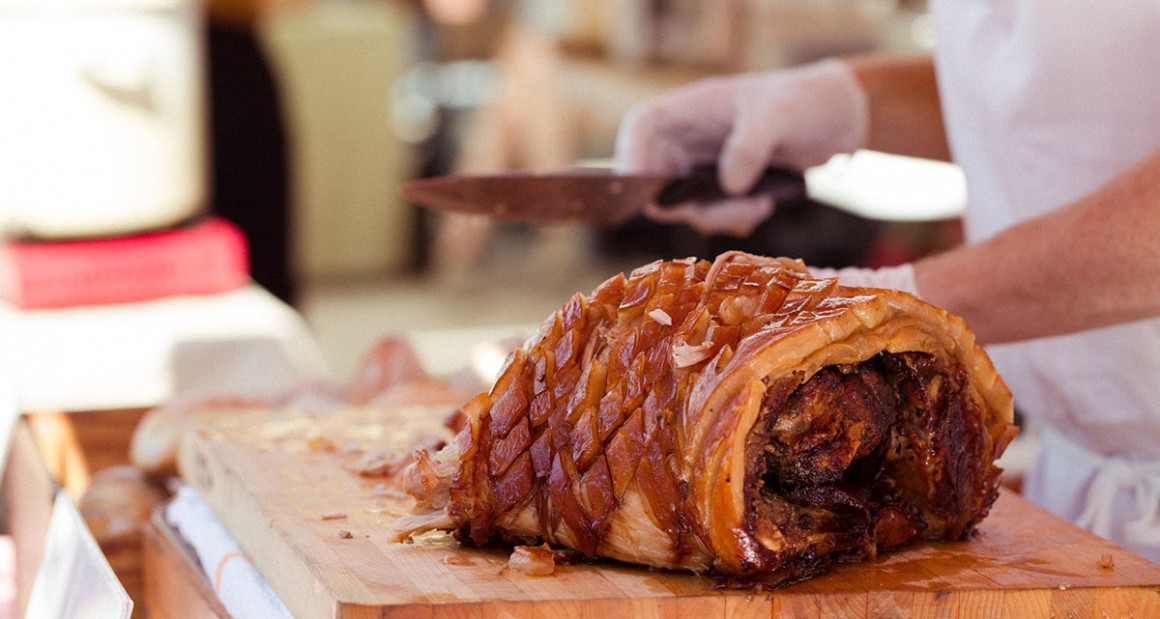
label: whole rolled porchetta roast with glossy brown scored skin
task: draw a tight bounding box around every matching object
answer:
[396,253,1016,587]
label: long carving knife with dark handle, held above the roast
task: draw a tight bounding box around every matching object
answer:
[401,165,806,226]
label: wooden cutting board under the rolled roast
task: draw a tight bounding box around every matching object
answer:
[180,408,1160,619]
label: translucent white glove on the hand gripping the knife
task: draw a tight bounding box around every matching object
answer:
[616,60,869,235]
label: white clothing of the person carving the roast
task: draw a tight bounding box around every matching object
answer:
[929,0,1160,560]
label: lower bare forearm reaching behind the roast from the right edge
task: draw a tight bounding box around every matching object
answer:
[915,151,1160,343]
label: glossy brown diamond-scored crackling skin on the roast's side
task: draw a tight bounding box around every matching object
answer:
[451,252,836,555]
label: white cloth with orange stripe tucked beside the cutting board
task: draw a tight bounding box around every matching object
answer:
[166,486,293,619]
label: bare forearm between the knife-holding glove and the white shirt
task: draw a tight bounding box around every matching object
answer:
[846,56,950,161]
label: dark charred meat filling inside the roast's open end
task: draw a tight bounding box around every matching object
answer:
[725,352,998,587]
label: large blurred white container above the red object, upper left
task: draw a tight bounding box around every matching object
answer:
[0,0,209,238]
